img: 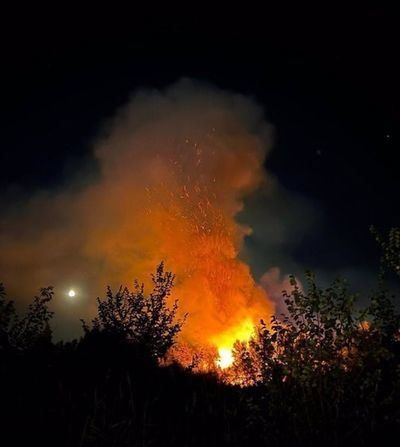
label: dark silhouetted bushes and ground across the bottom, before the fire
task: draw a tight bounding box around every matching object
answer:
[0,229,400,446]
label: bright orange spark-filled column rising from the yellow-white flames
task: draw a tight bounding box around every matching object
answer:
[141,150,272,360]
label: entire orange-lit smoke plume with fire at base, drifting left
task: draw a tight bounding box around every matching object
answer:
[0,80,273,367]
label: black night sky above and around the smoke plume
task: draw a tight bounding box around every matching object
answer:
[0,7,400,294]
